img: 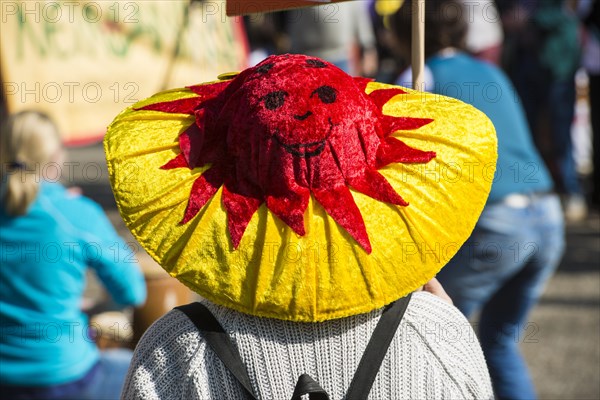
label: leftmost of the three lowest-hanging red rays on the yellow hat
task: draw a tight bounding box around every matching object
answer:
[223,186,262,249]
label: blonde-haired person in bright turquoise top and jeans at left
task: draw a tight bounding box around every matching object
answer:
[0,111,146,399]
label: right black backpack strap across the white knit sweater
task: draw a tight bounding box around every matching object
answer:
[346,293,412,400]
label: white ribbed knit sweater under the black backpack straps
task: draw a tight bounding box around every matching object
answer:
[122,292,493,400]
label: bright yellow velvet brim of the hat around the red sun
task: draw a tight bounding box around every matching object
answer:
[104,83,496,322]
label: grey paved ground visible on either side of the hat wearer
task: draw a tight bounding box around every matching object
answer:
[68,145,600,400]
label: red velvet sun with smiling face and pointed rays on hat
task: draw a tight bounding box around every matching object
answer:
[141,55,435,253]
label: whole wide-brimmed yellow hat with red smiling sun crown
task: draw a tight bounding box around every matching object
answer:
[104,55,496,322]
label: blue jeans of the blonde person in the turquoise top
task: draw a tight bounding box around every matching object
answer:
[0,349,133,400]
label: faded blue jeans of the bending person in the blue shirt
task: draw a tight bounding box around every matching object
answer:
[437,195,565,399]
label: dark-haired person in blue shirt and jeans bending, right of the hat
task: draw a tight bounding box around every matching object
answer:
[394,0,565,399]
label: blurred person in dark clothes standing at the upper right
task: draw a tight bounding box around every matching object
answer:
[496,0,587,221]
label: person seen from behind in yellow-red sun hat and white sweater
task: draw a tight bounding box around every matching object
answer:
[104,55,496,399]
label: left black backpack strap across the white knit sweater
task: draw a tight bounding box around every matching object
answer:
[175,303,257,399]
